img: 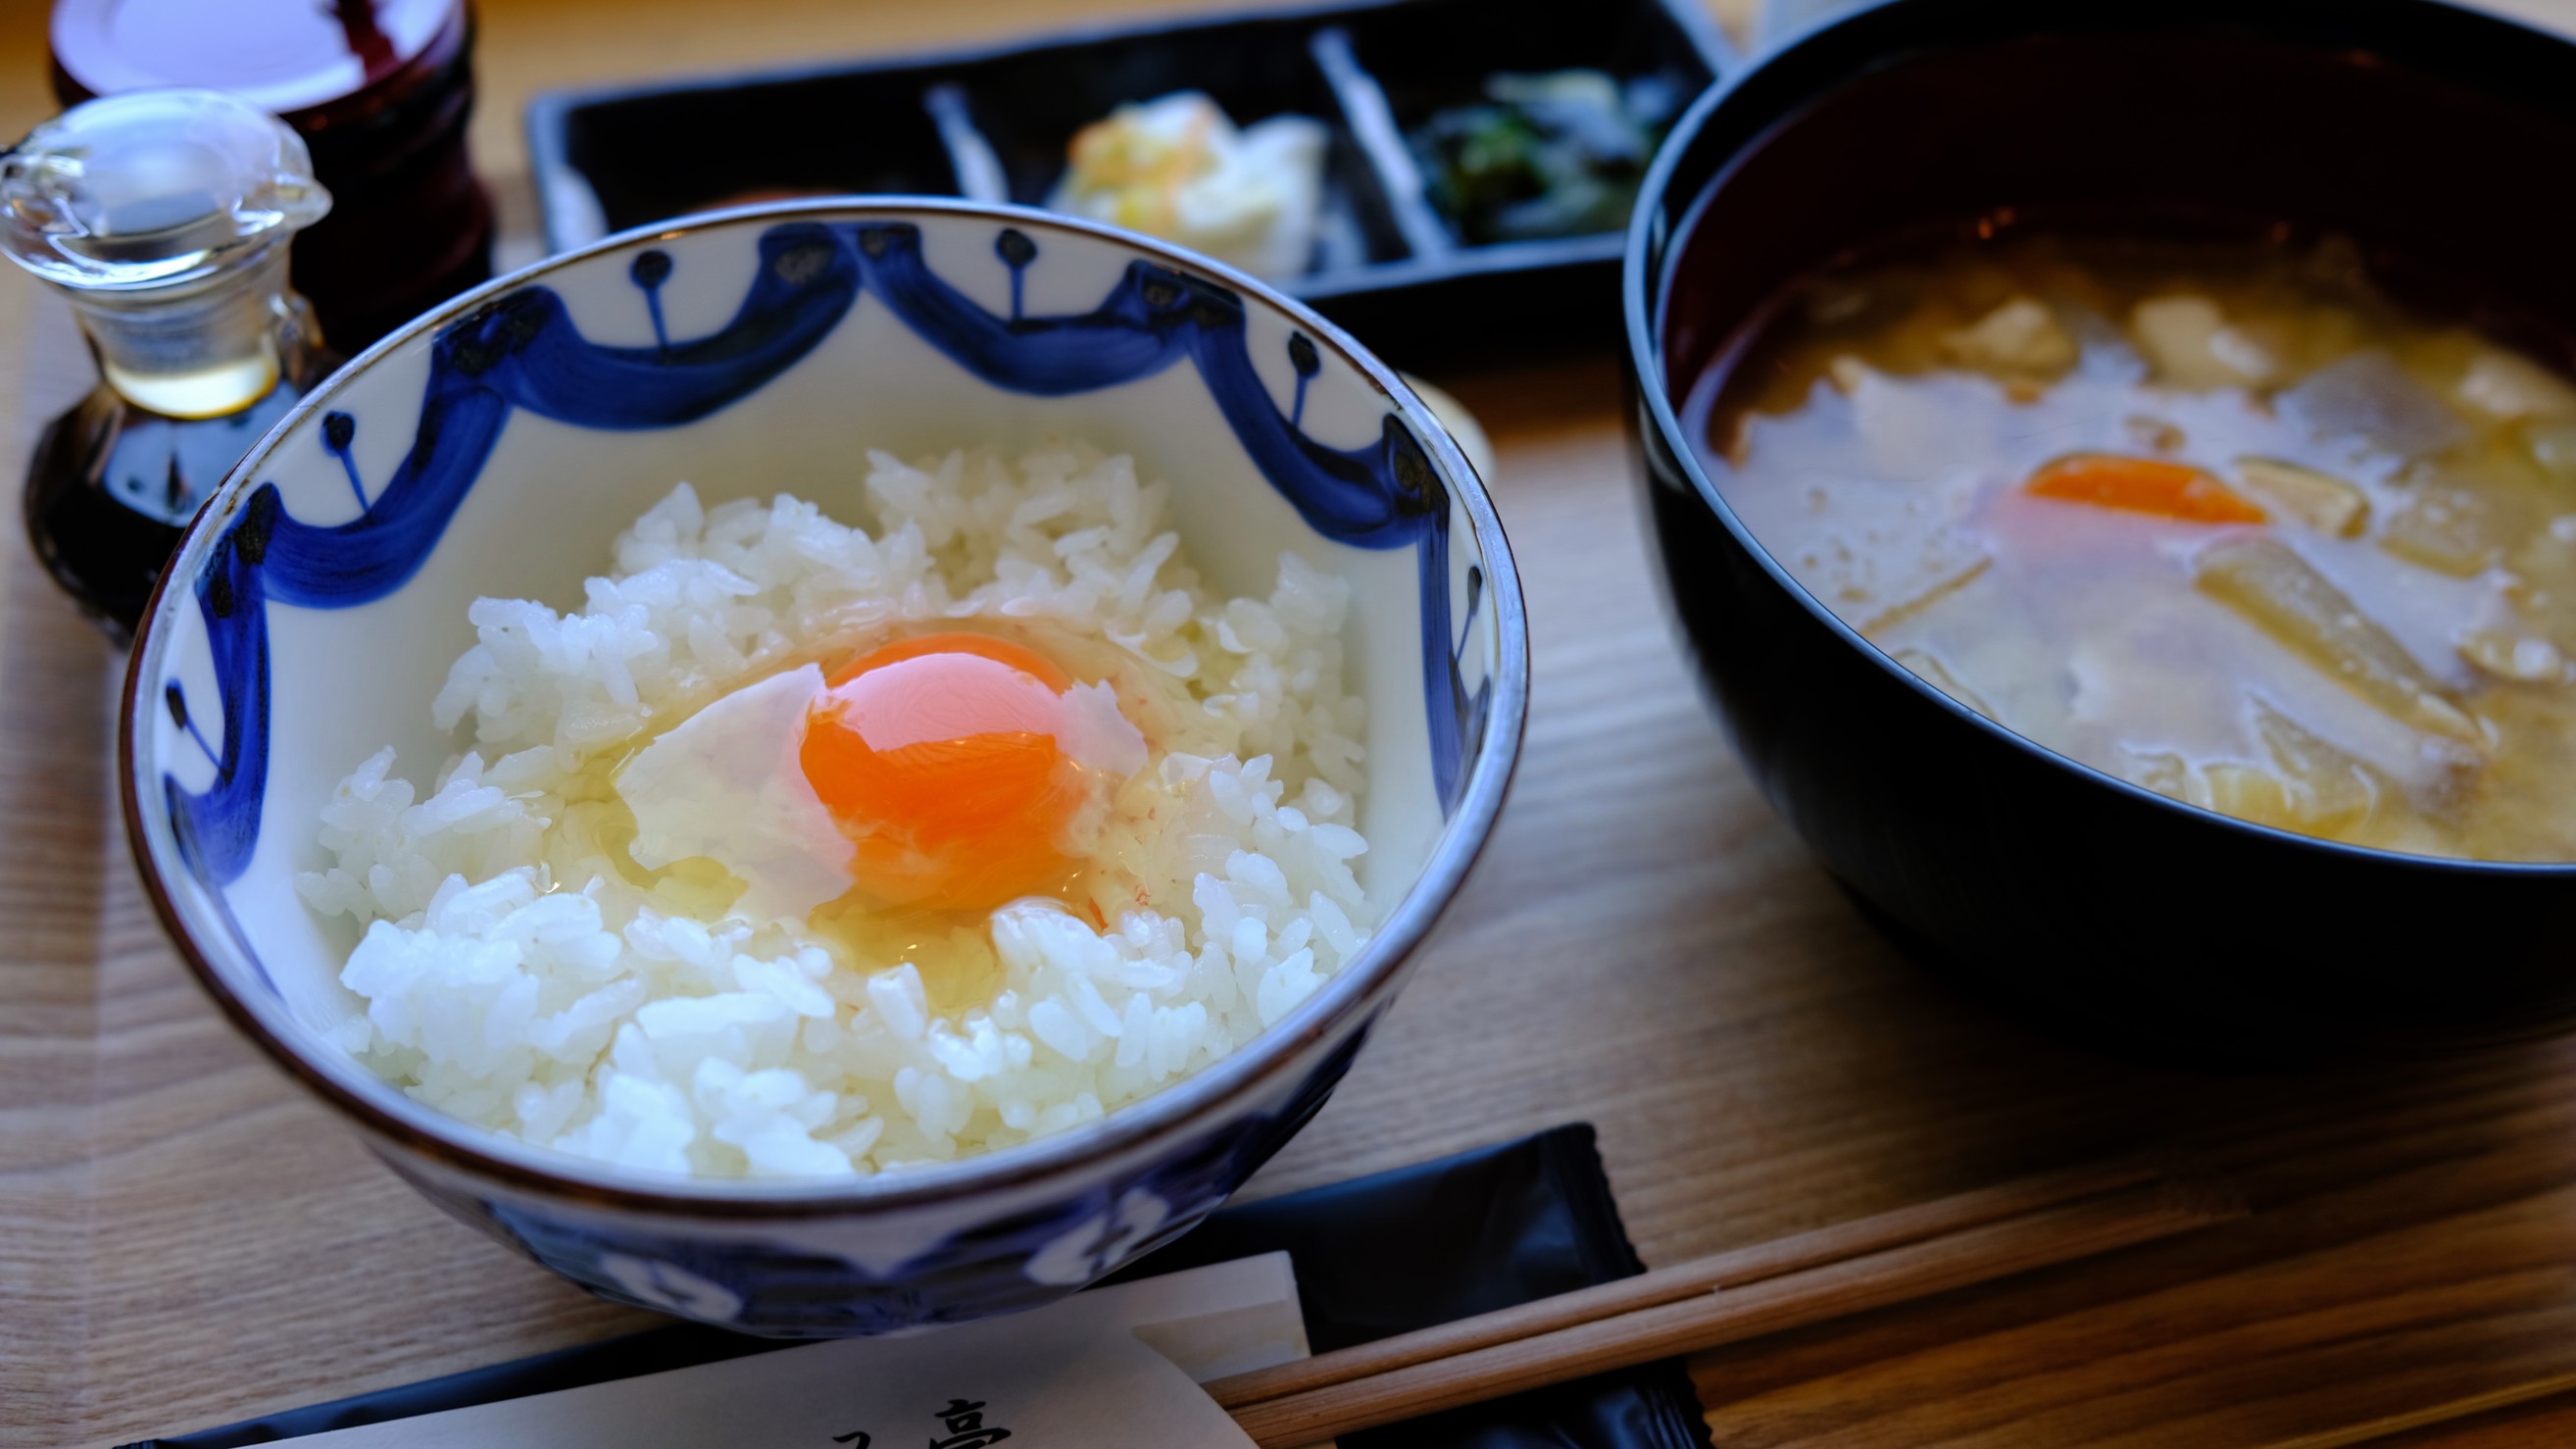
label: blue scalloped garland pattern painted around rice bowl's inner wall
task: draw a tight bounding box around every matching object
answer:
[163,222,1492,884]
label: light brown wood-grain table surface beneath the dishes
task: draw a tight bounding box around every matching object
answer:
[15,0,2576,1446]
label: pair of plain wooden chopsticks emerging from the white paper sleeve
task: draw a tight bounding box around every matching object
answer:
[1206,1163,2244,1449]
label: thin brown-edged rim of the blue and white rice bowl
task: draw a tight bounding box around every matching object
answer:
[116,196,1530,1220]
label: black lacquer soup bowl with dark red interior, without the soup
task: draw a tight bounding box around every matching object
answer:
[1625,0,2576,1060]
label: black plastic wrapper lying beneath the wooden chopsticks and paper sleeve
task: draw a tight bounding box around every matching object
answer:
[124,1124,1708,1449]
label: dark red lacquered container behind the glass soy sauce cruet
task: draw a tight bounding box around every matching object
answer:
[52,0,492,353]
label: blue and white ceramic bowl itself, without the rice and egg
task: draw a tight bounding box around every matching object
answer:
[122,201,1527,1335]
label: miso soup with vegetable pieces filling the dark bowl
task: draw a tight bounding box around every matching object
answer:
[1687,237,2576,861]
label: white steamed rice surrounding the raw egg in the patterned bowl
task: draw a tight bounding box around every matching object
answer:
[296,446,1373,1175]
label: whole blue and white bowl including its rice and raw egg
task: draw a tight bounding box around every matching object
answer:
[122,201,1527,1335]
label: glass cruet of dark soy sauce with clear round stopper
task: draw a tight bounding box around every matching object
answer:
[0,90,332,639]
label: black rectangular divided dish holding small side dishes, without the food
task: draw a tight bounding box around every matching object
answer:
[528,0,1734,366]
